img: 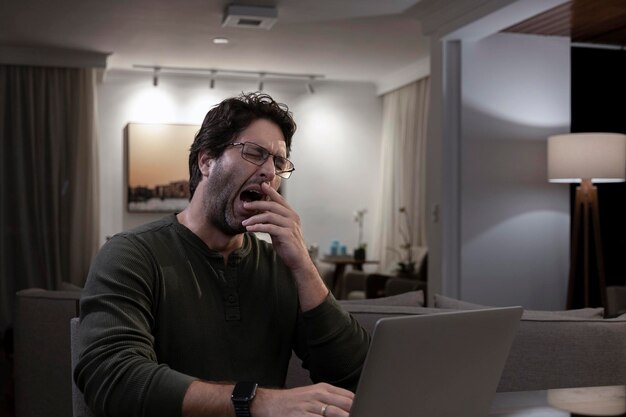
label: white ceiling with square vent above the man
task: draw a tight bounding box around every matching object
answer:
[0,0,429,82]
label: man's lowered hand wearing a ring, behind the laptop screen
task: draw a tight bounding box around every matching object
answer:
[251,384,354,417]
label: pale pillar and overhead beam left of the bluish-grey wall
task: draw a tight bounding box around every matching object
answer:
[411,0,567,303]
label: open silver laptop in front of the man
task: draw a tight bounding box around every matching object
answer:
[350,307,523,417]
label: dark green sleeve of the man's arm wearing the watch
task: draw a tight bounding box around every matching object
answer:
[74,236,196,416]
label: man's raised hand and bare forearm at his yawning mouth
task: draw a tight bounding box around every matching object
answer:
[242,183,328,311]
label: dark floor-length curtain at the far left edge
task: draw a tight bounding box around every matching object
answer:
[0,65,99,327]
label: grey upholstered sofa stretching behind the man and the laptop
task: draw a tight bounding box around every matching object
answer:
[15,290,626,417]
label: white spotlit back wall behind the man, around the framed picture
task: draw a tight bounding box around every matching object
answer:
[98,71,382,253]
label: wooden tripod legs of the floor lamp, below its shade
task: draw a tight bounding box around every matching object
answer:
[567,179,606,309]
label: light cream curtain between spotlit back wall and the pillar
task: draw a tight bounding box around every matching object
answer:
[374,77,430,271]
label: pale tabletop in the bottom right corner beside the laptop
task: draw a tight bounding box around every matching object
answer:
[489,385,626,417]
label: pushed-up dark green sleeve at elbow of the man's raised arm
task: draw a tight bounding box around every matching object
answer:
[295,293,370,392]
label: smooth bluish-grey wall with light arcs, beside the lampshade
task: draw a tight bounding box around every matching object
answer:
[460,34,570,310]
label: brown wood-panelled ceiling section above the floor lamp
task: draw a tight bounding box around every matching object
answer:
[505,0,626,46]
